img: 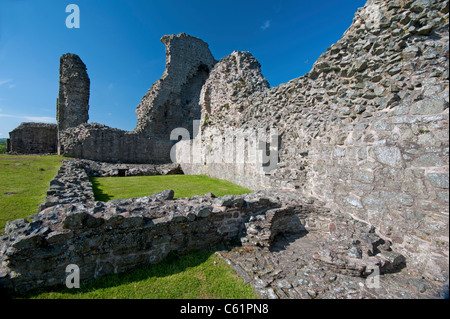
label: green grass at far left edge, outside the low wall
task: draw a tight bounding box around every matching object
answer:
[0,154,62,234]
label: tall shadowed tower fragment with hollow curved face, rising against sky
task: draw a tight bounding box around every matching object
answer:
[135,33,216,139]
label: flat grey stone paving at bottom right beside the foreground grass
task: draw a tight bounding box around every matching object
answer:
[217,231,442,299]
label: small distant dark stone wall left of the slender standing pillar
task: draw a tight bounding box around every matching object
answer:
[8,123,57,154]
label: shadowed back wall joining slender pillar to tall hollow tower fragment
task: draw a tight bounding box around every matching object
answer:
[58,33,216,163]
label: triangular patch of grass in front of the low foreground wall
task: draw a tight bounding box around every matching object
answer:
[29,250,259,299]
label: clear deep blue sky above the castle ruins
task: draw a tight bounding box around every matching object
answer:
[0,0,365,138]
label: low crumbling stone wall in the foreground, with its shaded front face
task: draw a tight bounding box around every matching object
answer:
[0,160,279,293]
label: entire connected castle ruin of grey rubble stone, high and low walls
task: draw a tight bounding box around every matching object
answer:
[0,0,449,298]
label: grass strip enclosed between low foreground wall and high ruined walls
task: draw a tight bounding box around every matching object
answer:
[90,175,251,202]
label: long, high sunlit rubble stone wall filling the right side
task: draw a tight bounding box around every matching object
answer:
[179,0,449,281]
